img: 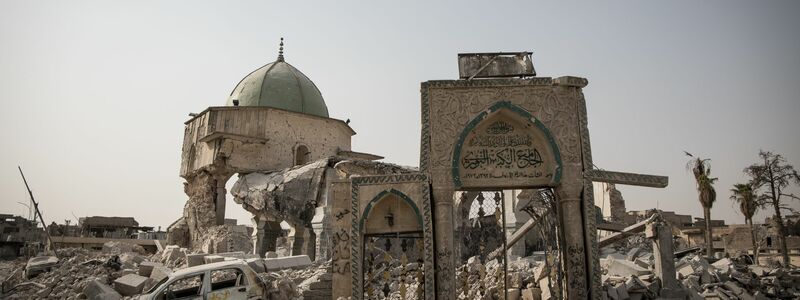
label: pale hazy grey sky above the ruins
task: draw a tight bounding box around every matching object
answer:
[0,0,800,230]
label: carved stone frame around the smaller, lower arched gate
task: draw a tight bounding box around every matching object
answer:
[350,173,436,300]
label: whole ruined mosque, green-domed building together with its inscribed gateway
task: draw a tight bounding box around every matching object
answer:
[167,39,675,299]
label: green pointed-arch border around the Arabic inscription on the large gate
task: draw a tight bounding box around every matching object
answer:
[451,101,564,190]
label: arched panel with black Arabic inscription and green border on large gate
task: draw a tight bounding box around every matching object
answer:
[453,101,561,189]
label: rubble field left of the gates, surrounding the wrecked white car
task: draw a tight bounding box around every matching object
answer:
[0,245,332,300]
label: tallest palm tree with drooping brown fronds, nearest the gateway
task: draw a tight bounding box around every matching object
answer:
[684,151,717,257]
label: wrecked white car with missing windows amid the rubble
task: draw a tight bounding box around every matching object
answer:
[135,260,267,300]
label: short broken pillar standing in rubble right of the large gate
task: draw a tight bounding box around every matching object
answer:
[644,220,685,299]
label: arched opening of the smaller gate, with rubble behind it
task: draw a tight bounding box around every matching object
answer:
[359,190,425,299]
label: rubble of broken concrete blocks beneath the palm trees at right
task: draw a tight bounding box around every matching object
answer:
[600,246,800,300]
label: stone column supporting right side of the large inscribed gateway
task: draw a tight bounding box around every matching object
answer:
[555,164,594,299]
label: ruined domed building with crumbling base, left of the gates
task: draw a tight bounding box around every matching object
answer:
[168,40,394,258]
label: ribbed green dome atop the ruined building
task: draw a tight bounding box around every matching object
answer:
[226,55,328,118]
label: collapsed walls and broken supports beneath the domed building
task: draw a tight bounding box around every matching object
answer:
[167,157,416,260]
